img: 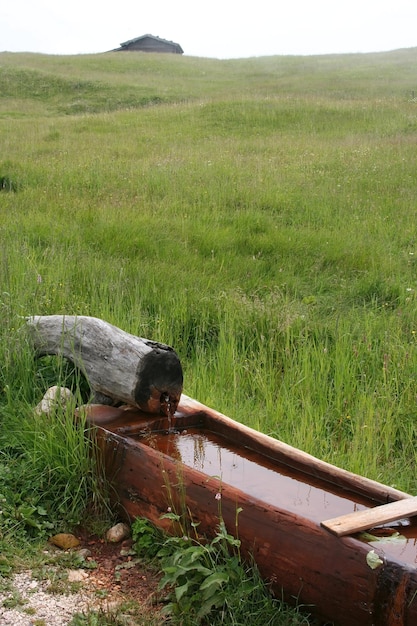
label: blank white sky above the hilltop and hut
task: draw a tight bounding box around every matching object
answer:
[0,0,417,58]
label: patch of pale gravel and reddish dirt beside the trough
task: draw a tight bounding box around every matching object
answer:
[0,533,165,626]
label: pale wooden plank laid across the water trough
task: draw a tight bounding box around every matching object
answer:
[321,497,417,537]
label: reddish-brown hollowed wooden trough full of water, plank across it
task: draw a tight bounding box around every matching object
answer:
[27,316,417,626]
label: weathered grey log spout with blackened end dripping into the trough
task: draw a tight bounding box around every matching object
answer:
[27,315,183,415]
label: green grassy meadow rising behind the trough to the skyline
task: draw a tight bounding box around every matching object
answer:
[0,49,417,556]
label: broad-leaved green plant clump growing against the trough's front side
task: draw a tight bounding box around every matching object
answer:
[149,502,308,626]
